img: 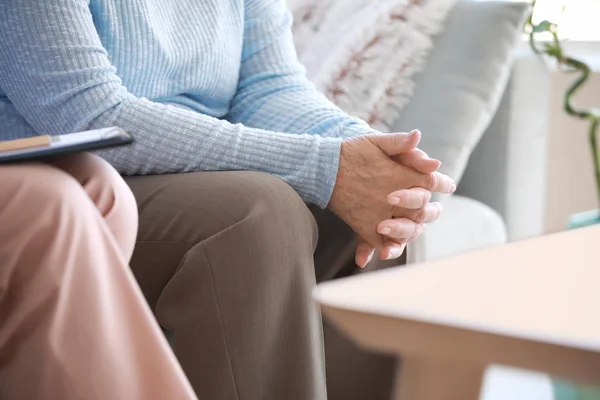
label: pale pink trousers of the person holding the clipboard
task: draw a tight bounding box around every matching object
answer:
[0,154,196,400]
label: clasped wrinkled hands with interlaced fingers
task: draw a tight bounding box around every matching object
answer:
[329,131,456,267]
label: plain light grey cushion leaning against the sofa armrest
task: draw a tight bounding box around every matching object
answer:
[393,0,528,181]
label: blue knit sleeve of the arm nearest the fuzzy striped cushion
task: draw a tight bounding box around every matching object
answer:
[228,0,373,138]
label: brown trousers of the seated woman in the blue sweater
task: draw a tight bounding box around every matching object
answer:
[127,172,404,400]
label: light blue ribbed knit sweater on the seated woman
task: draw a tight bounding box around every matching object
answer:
[0,0,376,207]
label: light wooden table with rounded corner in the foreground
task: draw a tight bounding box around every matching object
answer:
[314,226,600,400]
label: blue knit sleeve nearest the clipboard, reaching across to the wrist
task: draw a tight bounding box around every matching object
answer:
[0,0,341,207]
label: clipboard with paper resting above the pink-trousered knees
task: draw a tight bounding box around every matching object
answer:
[0,127,133,164]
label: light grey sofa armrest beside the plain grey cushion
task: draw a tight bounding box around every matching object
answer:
[458,49,551,241]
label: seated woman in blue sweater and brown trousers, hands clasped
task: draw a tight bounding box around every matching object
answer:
[0,0,455,400]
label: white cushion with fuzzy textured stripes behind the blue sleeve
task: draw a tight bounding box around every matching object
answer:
[288,0,457,133]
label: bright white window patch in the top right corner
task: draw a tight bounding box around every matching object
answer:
[534,0,600,41]
